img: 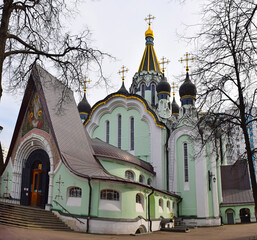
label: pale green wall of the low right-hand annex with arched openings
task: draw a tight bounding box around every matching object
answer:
[220,204,255,224]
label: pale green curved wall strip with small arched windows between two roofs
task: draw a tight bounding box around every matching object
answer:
[99,159,154,184]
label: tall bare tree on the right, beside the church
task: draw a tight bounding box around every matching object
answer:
[194,0,257,214]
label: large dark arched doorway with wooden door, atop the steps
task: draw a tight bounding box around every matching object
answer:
[20,149,50,208]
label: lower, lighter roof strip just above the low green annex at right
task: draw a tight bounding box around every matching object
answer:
[221,189,254,206]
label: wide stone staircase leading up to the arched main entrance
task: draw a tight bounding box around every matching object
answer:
[0,202,72,231]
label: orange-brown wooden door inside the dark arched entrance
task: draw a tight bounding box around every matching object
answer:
[30,169,42,206]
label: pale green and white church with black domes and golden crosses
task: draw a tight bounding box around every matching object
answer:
[0,16,255,234]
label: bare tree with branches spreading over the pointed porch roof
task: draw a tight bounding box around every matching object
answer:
[0,0,108,99]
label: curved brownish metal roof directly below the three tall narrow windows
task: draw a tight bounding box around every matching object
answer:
[92,138,154,173]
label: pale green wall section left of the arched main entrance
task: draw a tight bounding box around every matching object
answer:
[0,161,13,197]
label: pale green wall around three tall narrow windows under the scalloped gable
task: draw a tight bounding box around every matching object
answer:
[92,107,150,162]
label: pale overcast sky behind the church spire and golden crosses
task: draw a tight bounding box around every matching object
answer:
[0,0,201,147]
